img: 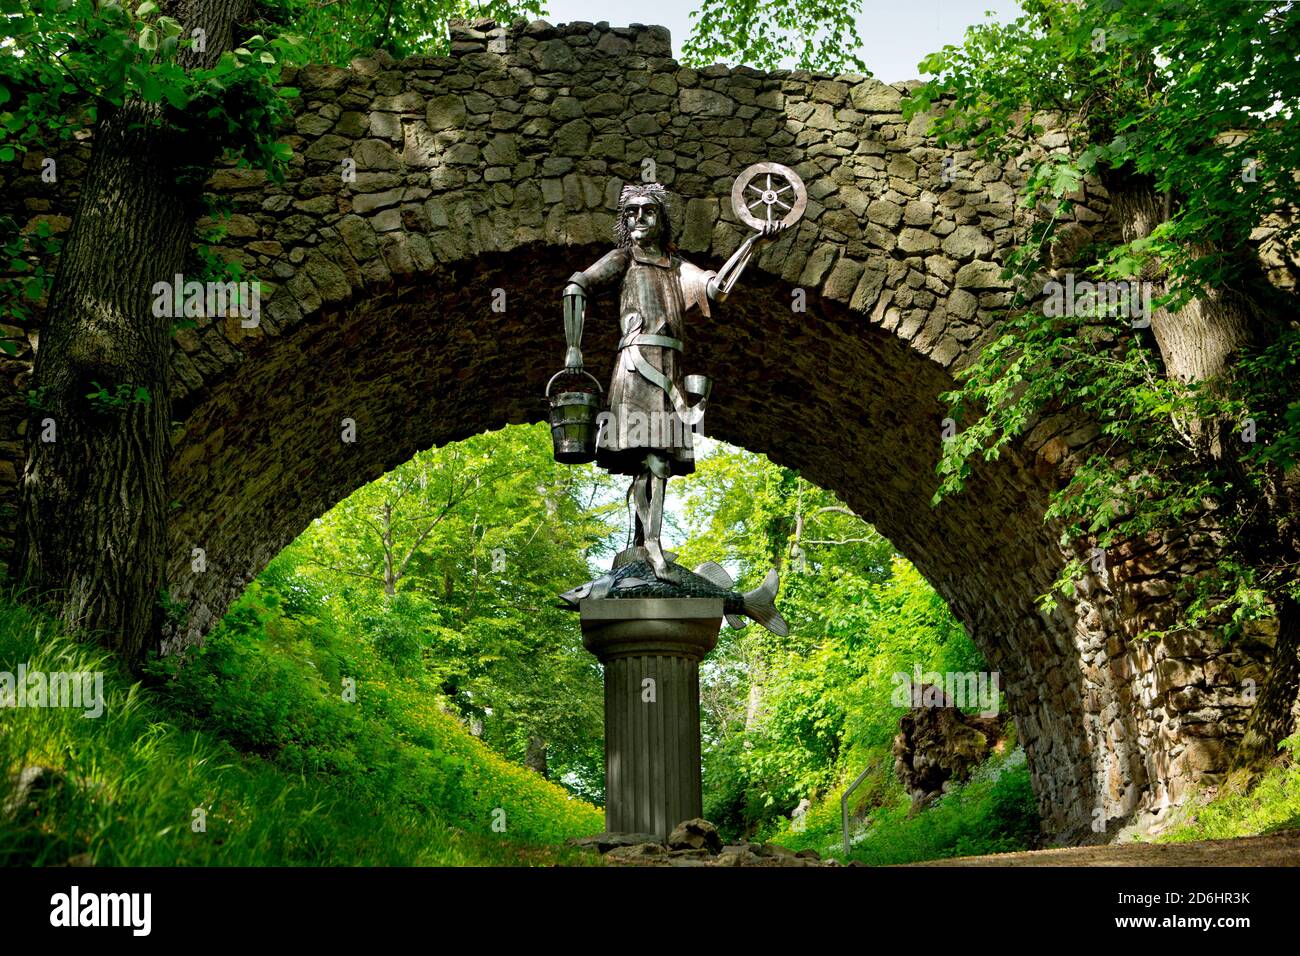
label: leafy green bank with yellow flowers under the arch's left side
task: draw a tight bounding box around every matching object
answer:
[144,566,599,843]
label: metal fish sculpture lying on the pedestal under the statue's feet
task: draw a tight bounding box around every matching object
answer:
[560,561,790,637]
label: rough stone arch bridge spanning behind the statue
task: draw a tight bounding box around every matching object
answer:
[0,16,1261,839]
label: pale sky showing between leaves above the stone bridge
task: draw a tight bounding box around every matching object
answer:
[546,0,1019,83]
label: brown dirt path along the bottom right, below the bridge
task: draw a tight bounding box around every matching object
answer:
[911,830,1300,866]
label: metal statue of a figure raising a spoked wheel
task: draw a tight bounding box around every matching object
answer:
[564,163,807,581]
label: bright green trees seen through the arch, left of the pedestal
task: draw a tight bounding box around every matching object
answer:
[287,425,611,800]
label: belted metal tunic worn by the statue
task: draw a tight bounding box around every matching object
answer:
[580,246,716,475]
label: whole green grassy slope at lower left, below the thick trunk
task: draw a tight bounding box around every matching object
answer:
[0,590,602,865]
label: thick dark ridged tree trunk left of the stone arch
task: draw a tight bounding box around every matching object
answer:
[17,0,251,665]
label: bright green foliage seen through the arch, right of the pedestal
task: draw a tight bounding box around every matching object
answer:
[679,447,983,836]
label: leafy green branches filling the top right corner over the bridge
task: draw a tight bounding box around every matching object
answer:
[907,0,1300,278]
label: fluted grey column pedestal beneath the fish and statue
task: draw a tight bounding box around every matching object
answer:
[580,598,723,840]
